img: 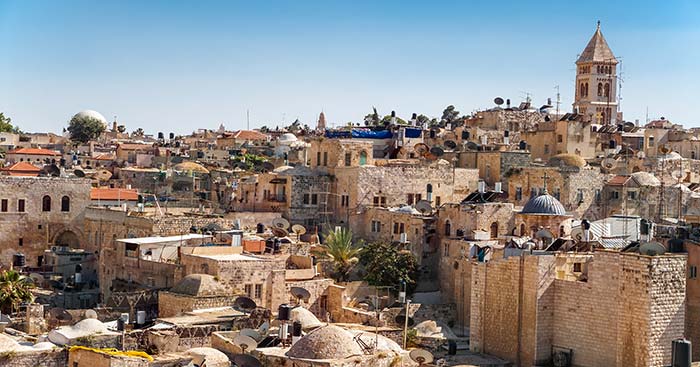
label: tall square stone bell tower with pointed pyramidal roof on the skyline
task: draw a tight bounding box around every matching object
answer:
[574,21,619,125]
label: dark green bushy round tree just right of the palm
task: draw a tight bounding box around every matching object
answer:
[360,242,418,291]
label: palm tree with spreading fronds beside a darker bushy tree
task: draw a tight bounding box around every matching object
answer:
[314,228,362,282]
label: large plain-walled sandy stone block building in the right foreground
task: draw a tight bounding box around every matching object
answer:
[470,251,686,367]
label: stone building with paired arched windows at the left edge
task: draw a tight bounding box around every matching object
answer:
[0,176,90,267]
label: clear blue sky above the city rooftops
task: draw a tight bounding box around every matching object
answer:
[0,0,700,133]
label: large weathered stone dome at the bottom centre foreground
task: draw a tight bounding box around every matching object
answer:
[287,325,362,359]
